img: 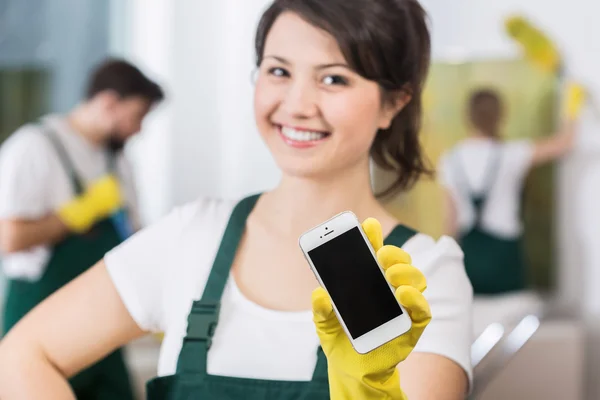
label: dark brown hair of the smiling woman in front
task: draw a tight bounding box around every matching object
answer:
[255,0,431,196]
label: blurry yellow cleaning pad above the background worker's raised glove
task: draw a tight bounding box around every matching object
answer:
[504,15,561,73]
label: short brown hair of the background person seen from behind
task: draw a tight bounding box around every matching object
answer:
[469,88,502,138]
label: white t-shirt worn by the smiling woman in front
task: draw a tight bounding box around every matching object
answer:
[104,199,472,381]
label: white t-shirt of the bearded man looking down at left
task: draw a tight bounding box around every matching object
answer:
[0,115,139,280]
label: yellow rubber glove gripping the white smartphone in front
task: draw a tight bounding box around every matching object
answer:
[312,218,431,400]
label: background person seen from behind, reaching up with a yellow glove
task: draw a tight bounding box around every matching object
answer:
[439,84,585,294]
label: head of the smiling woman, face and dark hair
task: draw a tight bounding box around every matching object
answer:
[254,1,430,194]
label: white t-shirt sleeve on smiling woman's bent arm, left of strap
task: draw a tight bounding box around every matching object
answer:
[104,197,244,331]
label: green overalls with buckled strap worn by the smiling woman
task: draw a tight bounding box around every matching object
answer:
[147,195,415,400]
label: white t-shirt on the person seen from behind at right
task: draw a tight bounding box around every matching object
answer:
[439,138,534,238]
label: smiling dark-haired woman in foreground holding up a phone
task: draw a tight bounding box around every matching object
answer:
[0,0,472,400]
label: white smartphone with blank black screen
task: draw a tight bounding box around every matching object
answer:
[299,211,411,354]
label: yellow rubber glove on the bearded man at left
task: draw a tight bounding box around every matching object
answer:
[57,175,122,233]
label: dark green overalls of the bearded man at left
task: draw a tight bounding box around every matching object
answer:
[3,129,134,400]
